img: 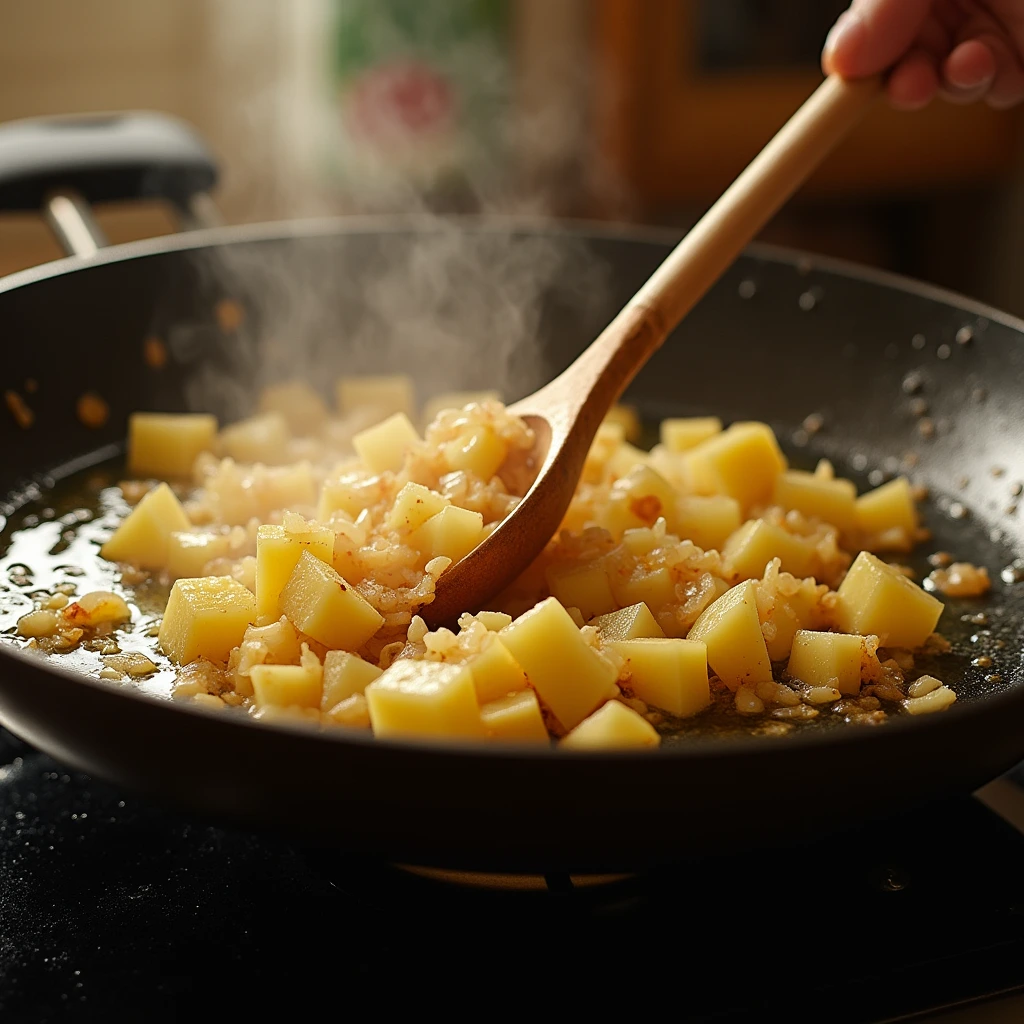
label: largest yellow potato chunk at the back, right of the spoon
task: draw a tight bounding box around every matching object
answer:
[684,423,786,511]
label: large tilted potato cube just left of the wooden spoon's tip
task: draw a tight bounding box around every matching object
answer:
[281,550,384,650]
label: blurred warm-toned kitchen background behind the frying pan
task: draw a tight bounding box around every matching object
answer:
[0,0,1024,314]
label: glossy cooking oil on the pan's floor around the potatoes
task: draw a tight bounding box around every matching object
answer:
[0,436,1024,741]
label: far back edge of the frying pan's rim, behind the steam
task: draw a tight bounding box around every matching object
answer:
[0,214,1024,335]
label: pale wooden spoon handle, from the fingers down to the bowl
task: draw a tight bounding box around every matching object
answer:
[536,77,882,436]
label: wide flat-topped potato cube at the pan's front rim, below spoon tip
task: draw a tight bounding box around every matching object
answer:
[366,658,484,738]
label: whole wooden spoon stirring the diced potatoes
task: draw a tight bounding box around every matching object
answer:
[422,76,882,625]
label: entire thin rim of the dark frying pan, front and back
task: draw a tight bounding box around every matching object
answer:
[0,215,1024,764]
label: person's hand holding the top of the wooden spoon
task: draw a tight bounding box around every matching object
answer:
[821,0,1024,111]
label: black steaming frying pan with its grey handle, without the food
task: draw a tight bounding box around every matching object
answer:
[0,116,1024,871]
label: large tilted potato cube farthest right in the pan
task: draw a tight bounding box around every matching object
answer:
[836,551,942,648]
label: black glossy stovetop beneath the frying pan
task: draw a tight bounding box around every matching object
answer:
[0,730,1024,1024]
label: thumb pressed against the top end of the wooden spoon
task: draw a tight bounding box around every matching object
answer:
[821,0,932,78]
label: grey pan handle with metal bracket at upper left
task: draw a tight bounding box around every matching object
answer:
[0,112,218,256]
